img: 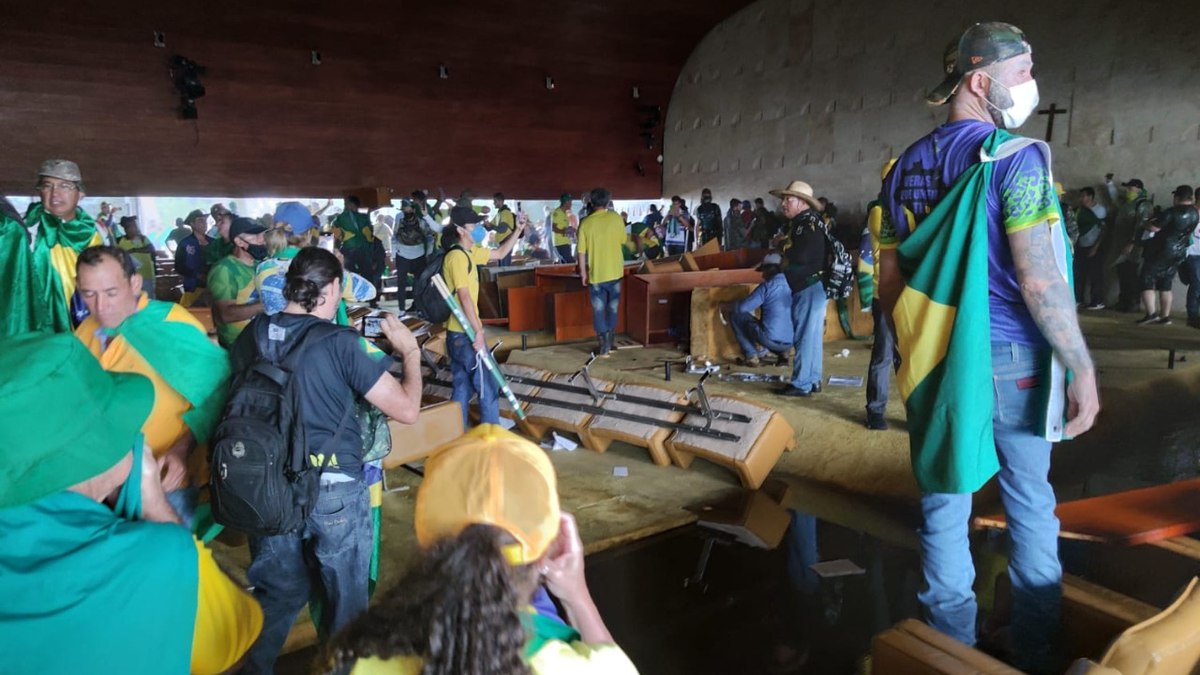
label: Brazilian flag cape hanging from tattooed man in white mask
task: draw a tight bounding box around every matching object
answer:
[892,130,1070,492]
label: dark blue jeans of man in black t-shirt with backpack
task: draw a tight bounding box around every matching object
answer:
[242,480,372,674]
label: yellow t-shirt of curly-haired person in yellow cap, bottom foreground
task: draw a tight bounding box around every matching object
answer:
[350,640,637,675]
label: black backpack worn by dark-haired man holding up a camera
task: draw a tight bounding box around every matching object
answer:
[210,317,354,537]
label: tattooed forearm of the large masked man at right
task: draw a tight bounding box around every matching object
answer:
[1009,223,1092,371]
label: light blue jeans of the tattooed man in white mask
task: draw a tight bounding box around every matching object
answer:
[918,342,1062,670]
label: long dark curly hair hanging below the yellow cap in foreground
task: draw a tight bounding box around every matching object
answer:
[317,525,536,675]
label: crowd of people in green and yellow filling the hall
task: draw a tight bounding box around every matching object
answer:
[7,13,1200,675]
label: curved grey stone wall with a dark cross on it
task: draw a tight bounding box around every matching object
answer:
[664,0,1200,221]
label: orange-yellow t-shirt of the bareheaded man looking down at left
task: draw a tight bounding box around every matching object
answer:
[74,293,199,458]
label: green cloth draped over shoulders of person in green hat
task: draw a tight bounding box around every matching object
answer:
[0,487,199,675]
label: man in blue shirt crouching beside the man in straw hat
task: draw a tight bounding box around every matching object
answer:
[730,253,794,368]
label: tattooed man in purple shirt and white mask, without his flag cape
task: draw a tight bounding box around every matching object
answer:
[880,23,1099,673]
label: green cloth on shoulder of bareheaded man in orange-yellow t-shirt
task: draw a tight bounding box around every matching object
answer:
[114,300,229,444]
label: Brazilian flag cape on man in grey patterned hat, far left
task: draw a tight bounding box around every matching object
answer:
[22,203,101,333]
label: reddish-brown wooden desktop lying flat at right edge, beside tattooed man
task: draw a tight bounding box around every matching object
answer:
[974,478,1200,546]
